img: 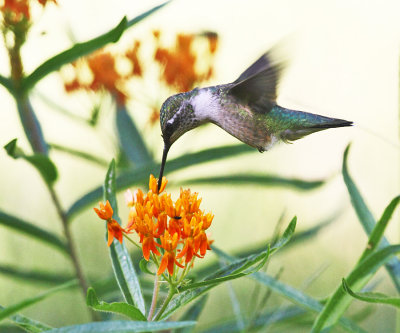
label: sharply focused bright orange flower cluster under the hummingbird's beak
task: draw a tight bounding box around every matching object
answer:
[95,175,214,275]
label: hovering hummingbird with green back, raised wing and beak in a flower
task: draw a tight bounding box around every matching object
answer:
[158,50,353,185]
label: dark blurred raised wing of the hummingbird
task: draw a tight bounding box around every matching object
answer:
[229,52,284,113]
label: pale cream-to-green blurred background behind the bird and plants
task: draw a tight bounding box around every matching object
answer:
[0,0,400,332]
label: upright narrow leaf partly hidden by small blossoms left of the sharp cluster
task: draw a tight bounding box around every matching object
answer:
[104,160,146,315]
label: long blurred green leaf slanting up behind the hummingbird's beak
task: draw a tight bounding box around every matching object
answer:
[67,145,254,220]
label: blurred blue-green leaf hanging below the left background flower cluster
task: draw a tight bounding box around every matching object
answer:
[116,105,153,166]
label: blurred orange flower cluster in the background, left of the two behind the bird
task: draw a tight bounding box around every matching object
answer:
[64,46,142,105]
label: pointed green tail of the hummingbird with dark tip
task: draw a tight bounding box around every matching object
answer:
[271,107,353,142]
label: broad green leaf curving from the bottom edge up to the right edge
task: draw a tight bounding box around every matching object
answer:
[313,245,400,332]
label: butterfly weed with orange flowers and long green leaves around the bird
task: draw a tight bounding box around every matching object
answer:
[0,0,400,333]
